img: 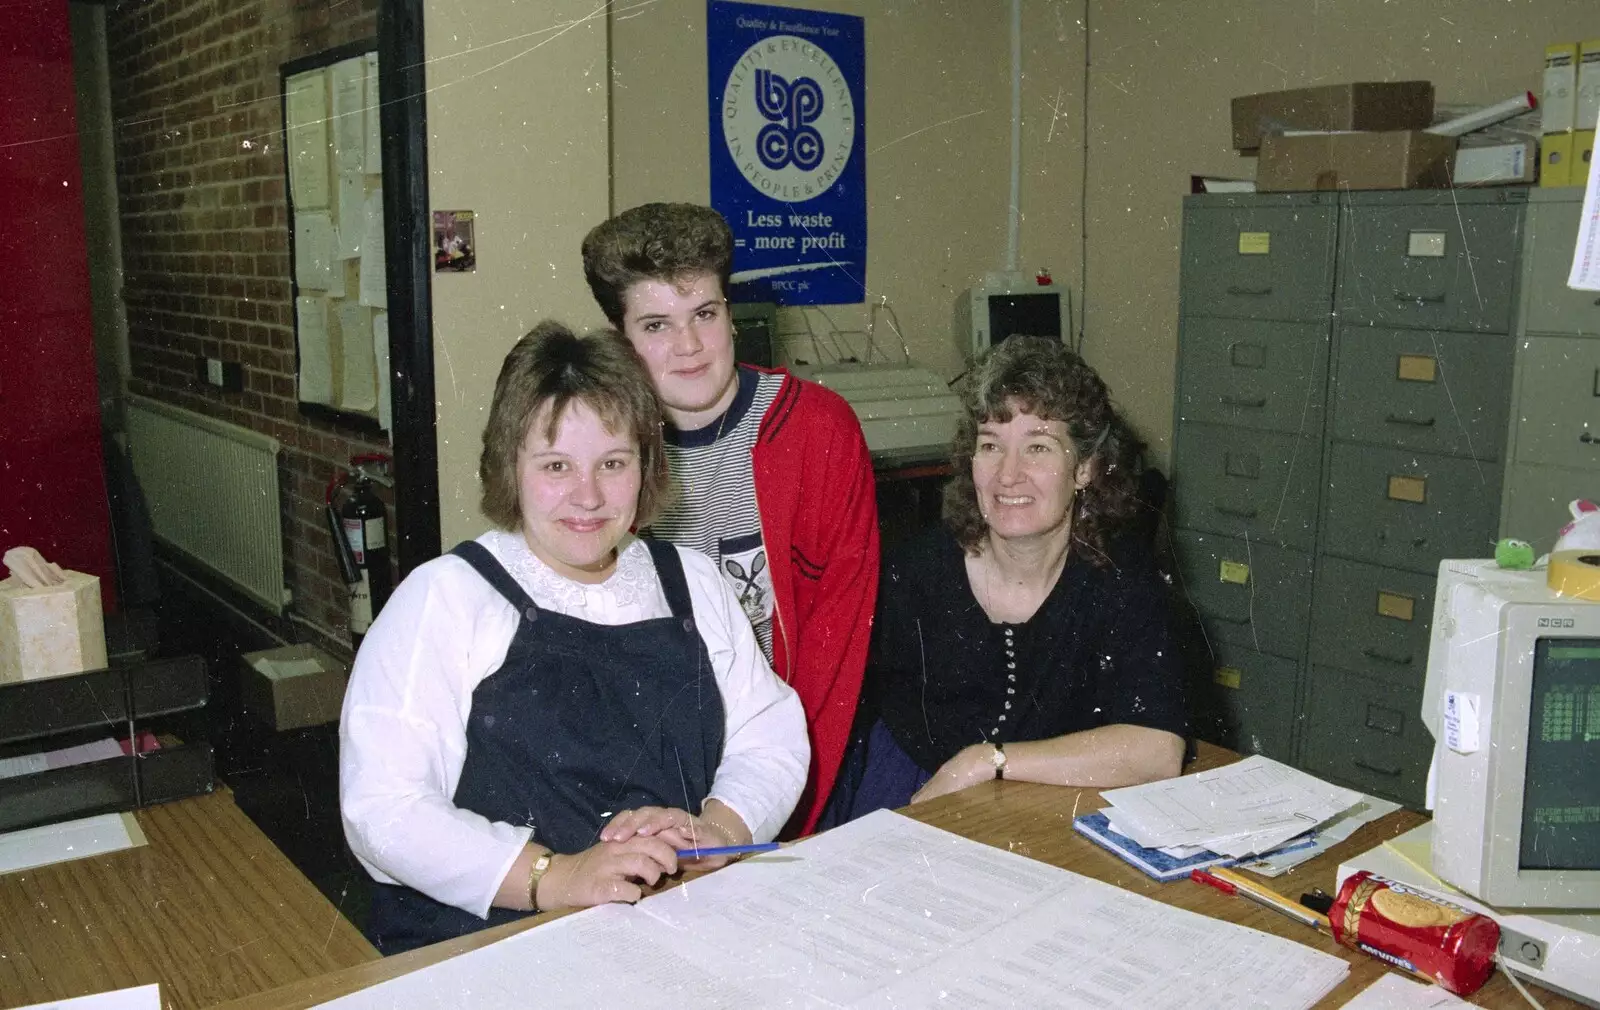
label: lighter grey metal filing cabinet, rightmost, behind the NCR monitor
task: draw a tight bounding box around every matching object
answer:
[1499,189,1600,554]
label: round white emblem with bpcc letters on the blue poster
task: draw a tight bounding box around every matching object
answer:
[722,35,856,203]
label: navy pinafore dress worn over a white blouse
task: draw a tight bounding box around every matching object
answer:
[366,539,723,956]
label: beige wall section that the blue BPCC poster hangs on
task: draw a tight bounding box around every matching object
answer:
[611,0,1083,378]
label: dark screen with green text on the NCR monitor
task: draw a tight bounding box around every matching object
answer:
[1520,639,1600,869]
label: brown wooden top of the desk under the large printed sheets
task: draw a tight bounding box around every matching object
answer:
[206,744,1579,1010]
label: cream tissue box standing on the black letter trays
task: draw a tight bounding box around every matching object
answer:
[0,570,106,683]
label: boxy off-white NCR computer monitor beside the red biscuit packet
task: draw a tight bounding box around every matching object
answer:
[1422,560,1600,909]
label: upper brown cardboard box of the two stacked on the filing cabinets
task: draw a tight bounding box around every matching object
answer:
[1234,80,1434,150]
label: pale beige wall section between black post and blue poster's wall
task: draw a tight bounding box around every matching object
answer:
[424,0,608,549]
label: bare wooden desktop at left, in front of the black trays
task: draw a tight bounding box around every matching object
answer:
[0,789,378,1010]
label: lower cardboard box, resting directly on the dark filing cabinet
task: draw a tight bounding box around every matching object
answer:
[1256,130,1456,192]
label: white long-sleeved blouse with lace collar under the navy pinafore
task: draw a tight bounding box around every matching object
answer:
[339,531,811,916]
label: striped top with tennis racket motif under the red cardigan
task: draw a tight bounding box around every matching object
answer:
[645,368,784,663]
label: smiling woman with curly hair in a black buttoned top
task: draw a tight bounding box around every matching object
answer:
[829,336,1186,821]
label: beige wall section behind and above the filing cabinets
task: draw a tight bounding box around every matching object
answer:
[1077,0,1600,459]
